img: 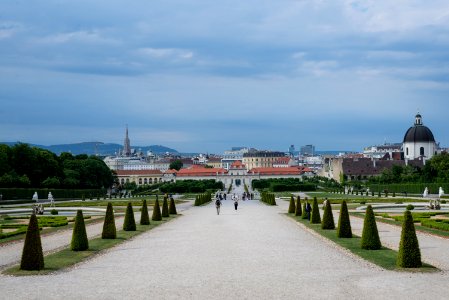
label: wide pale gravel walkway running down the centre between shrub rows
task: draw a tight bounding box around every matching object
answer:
[0,200,449,299]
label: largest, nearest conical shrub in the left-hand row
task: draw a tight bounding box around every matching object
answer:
[20,214,44,271]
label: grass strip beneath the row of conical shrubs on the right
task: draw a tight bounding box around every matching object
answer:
[287,214,438,272]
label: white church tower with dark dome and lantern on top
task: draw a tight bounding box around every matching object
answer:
[402,113,437,161]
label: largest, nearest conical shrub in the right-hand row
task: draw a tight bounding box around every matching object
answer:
[396,210,422,268]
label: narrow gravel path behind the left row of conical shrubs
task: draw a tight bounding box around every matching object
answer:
[0,202,192,270]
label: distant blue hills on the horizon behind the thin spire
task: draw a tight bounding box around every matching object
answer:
[0,142,178,156]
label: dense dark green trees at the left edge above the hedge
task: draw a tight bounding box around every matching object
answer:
[0,143,114,189]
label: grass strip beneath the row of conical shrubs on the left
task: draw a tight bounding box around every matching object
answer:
[3,215,179,276]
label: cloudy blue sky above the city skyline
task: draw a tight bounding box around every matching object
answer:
[0,0,449,153]
